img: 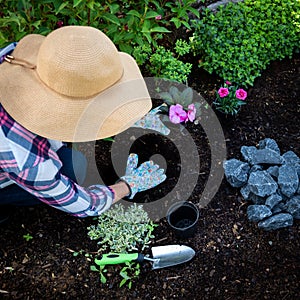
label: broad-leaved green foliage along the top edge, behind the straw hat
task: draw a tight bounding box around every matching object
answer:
[0,0,199,53]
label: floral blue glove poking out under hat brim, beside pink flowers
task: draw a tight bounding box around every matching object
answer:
[131,104,170,135]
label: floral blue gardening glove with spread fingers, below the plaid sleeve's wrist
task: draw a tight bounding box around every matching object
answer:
[121,153,167,199]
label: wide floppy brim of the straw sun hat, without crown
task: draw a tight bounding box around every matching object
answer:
[0,34,152,142]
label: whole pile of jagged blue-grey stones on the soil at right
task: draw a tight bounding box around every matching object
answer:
[223,138,300,231]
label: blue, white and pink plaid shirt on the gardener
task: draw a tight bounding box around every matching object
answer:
[0,104,114,217]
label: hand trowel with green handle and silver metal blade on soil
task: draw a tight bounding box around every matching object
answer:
[95,245,195,269]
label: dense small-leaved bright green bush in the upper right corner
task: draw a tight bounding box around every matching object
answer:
[190,0,300,86]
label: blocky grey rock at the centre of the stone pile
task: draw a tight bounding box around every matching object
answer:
[248,171,278,197]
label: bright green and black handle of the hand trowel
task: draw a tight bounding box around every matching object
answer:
[95,253,144,266]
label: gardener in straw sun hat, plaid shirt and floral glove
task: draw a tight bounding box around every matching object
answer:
[0,26,166,222]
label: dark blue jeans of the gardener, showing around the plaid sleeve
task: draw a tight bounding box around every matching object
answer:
[0,146,87,209]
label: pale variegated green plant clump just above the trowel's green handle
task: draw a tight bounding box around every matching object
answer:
[88,203,157,253]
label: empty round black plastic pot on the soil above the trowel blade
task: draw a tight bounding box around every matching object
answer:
[167,201,199,238]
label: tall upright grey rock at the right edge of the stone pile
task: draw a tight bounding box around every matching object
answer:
[278,165,299,197]
